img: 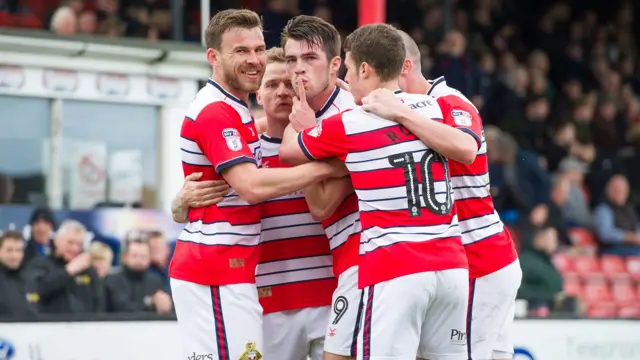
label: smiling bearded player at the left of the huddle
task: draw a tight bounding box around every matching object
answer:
[169,9,344,360]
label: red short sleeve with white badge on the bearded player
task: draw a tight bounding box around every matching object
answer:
[195,101,256,174]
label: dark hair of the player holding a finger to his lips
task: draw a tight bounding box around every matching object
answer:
[280,15,342,60]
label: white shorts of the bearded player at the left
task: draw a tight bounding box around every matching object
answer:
[171,279,264,360]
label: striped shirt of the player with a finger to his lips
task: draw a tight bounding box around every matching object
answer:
[316,86,362,276]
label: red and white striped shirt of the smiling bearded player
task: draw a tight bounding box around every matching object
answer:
[169,80,262,285]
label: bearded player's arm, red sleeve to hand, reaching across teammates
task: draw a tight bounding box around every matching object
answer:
[198,102,342,204]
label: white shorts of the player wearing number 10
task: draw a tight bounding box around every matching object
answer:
[357,269,469,360]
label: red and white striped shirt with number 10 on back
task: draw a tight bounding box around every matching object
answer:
[298,92,467,288]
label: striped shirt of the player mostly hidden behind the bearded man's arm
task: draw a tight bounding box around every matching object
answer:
[256,134,338,314]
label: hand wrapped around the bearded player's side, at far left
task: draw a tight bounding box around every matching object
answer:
[178,172,229,208]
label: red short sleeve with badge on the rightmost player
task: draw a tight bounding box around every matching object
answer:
[438,96,482,149]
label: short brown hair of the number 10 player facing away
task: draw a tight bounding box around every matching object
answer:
[344,24,407,81]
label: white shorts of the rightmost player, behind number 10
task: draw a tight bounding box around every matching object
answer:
[467,259,522,360]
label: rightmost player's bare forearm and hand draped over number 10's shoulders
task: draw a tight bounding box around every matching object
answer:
[362,89,479,164]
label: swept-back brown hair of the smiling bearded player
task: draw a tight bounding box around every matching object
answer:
[204,9,262,50]
